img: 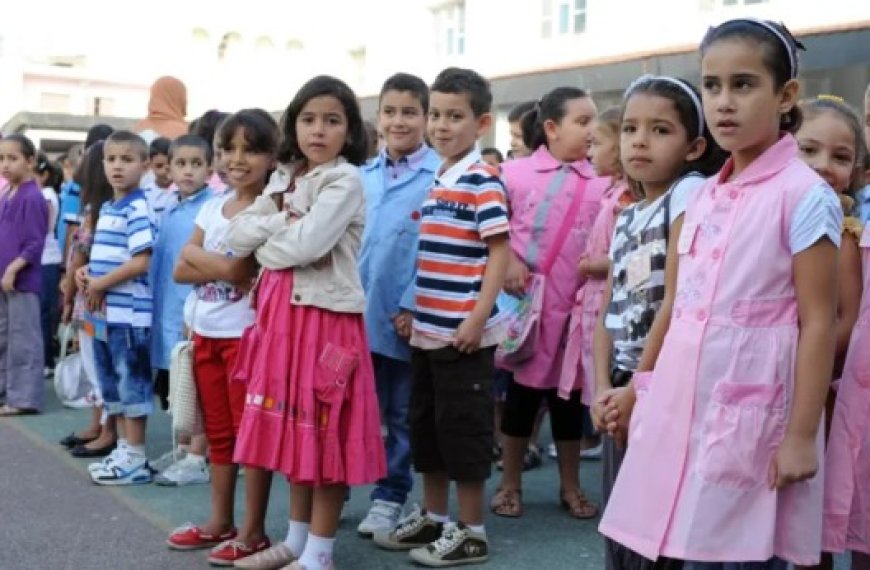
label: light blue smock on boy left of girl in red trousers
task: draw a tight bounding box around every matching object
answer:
[149,187,214,369]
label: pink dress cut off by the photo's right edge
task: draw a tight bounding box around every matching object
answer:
[823,226,870,554]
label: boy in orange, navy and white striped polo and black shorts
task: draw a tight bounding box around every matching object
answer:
[375,68,508,567]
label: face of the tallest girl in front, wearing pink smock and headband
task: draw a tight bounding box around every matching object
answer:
[701,39,798,162]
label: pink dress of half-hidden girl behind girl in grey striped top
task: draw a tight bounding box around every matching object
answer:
[559,183,631,400]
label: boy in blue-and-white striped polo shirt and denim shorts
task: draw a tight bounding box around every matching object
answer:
[77,131,154,485]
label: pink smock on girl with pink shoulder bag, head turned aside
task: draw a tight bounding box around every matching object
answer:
[498,145,609,389]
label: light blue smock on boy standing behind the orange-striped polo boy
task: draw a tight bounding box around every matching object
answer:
[359,145,441,361]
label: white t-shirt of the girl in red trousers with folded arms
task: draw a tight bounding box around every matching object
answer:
[184,192,254,338]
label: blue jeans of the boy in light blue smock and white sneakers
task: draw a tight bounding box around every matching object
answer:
[371,353,414,505]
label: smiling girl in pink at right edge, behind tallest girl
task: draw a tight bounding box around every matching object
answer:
[797,96,870,570]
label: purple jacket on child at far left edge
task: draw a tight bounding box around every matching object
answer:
[0,180,48,294]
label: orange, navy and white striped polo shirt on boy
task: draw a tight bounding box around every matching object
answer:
[414,150,509,340]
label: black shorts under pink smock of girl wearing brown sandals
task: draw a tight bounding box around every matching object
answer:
[501,380,583,441]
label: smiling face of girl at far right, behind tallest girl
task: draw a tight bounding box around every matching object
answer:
[797,111,857,193]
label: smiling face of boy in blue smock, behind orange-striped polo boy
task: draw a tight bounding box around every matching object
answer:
[378,90,426,156]
